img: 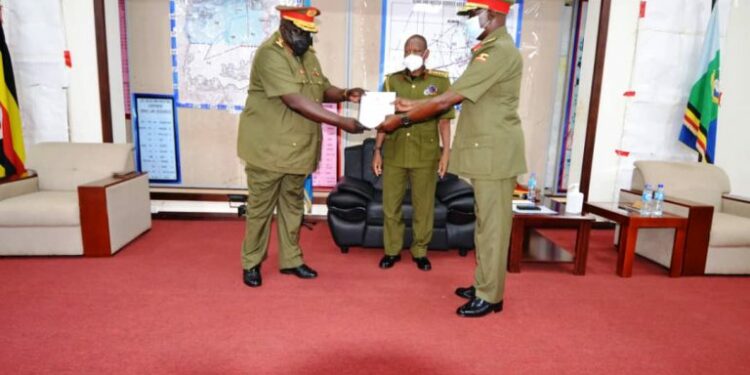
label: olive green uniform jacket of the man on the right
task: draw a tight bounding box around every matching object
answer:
[449,27,526,179]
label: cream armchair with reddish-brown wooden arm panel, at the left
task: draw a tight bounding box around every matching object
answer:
[0,143,151,256]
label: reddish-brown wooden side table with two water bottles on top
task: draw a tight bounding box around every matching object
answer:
[583,203,687,277]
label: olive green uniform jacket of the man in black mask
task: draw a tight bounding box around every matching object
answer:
[237,31,331,174]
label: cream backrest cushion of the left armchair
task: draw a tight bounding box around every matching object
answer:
[26,142,133,191]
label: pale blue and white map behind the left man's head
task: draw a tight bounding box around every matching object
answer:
[170,0,304,111]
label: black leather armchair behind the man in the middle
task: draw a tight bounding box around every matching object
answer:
[327,138,475,256]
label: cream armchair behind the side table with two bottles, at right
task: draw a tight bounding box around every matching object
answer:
[620,161,750,275]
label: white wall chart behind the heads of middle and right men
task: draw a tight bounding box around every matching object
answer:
[380,0,523,81]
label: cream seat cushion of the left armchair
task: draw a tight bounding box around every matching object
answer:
[0,191,81,227]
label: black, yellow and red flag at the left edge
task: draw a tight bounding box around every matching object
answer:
[0,23,26,177]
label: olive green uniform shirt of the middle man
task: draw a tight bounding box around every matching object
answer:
[383,70,455,168]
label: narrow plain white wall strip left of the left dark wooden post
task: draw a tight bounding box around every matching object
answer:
[62,0,102,142]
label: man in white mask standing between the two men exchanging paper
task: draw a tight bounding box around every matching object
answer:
[372,35,455,271]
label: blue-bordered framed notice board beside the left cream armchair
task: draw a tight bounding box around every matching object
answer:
[132,94,181,184]
